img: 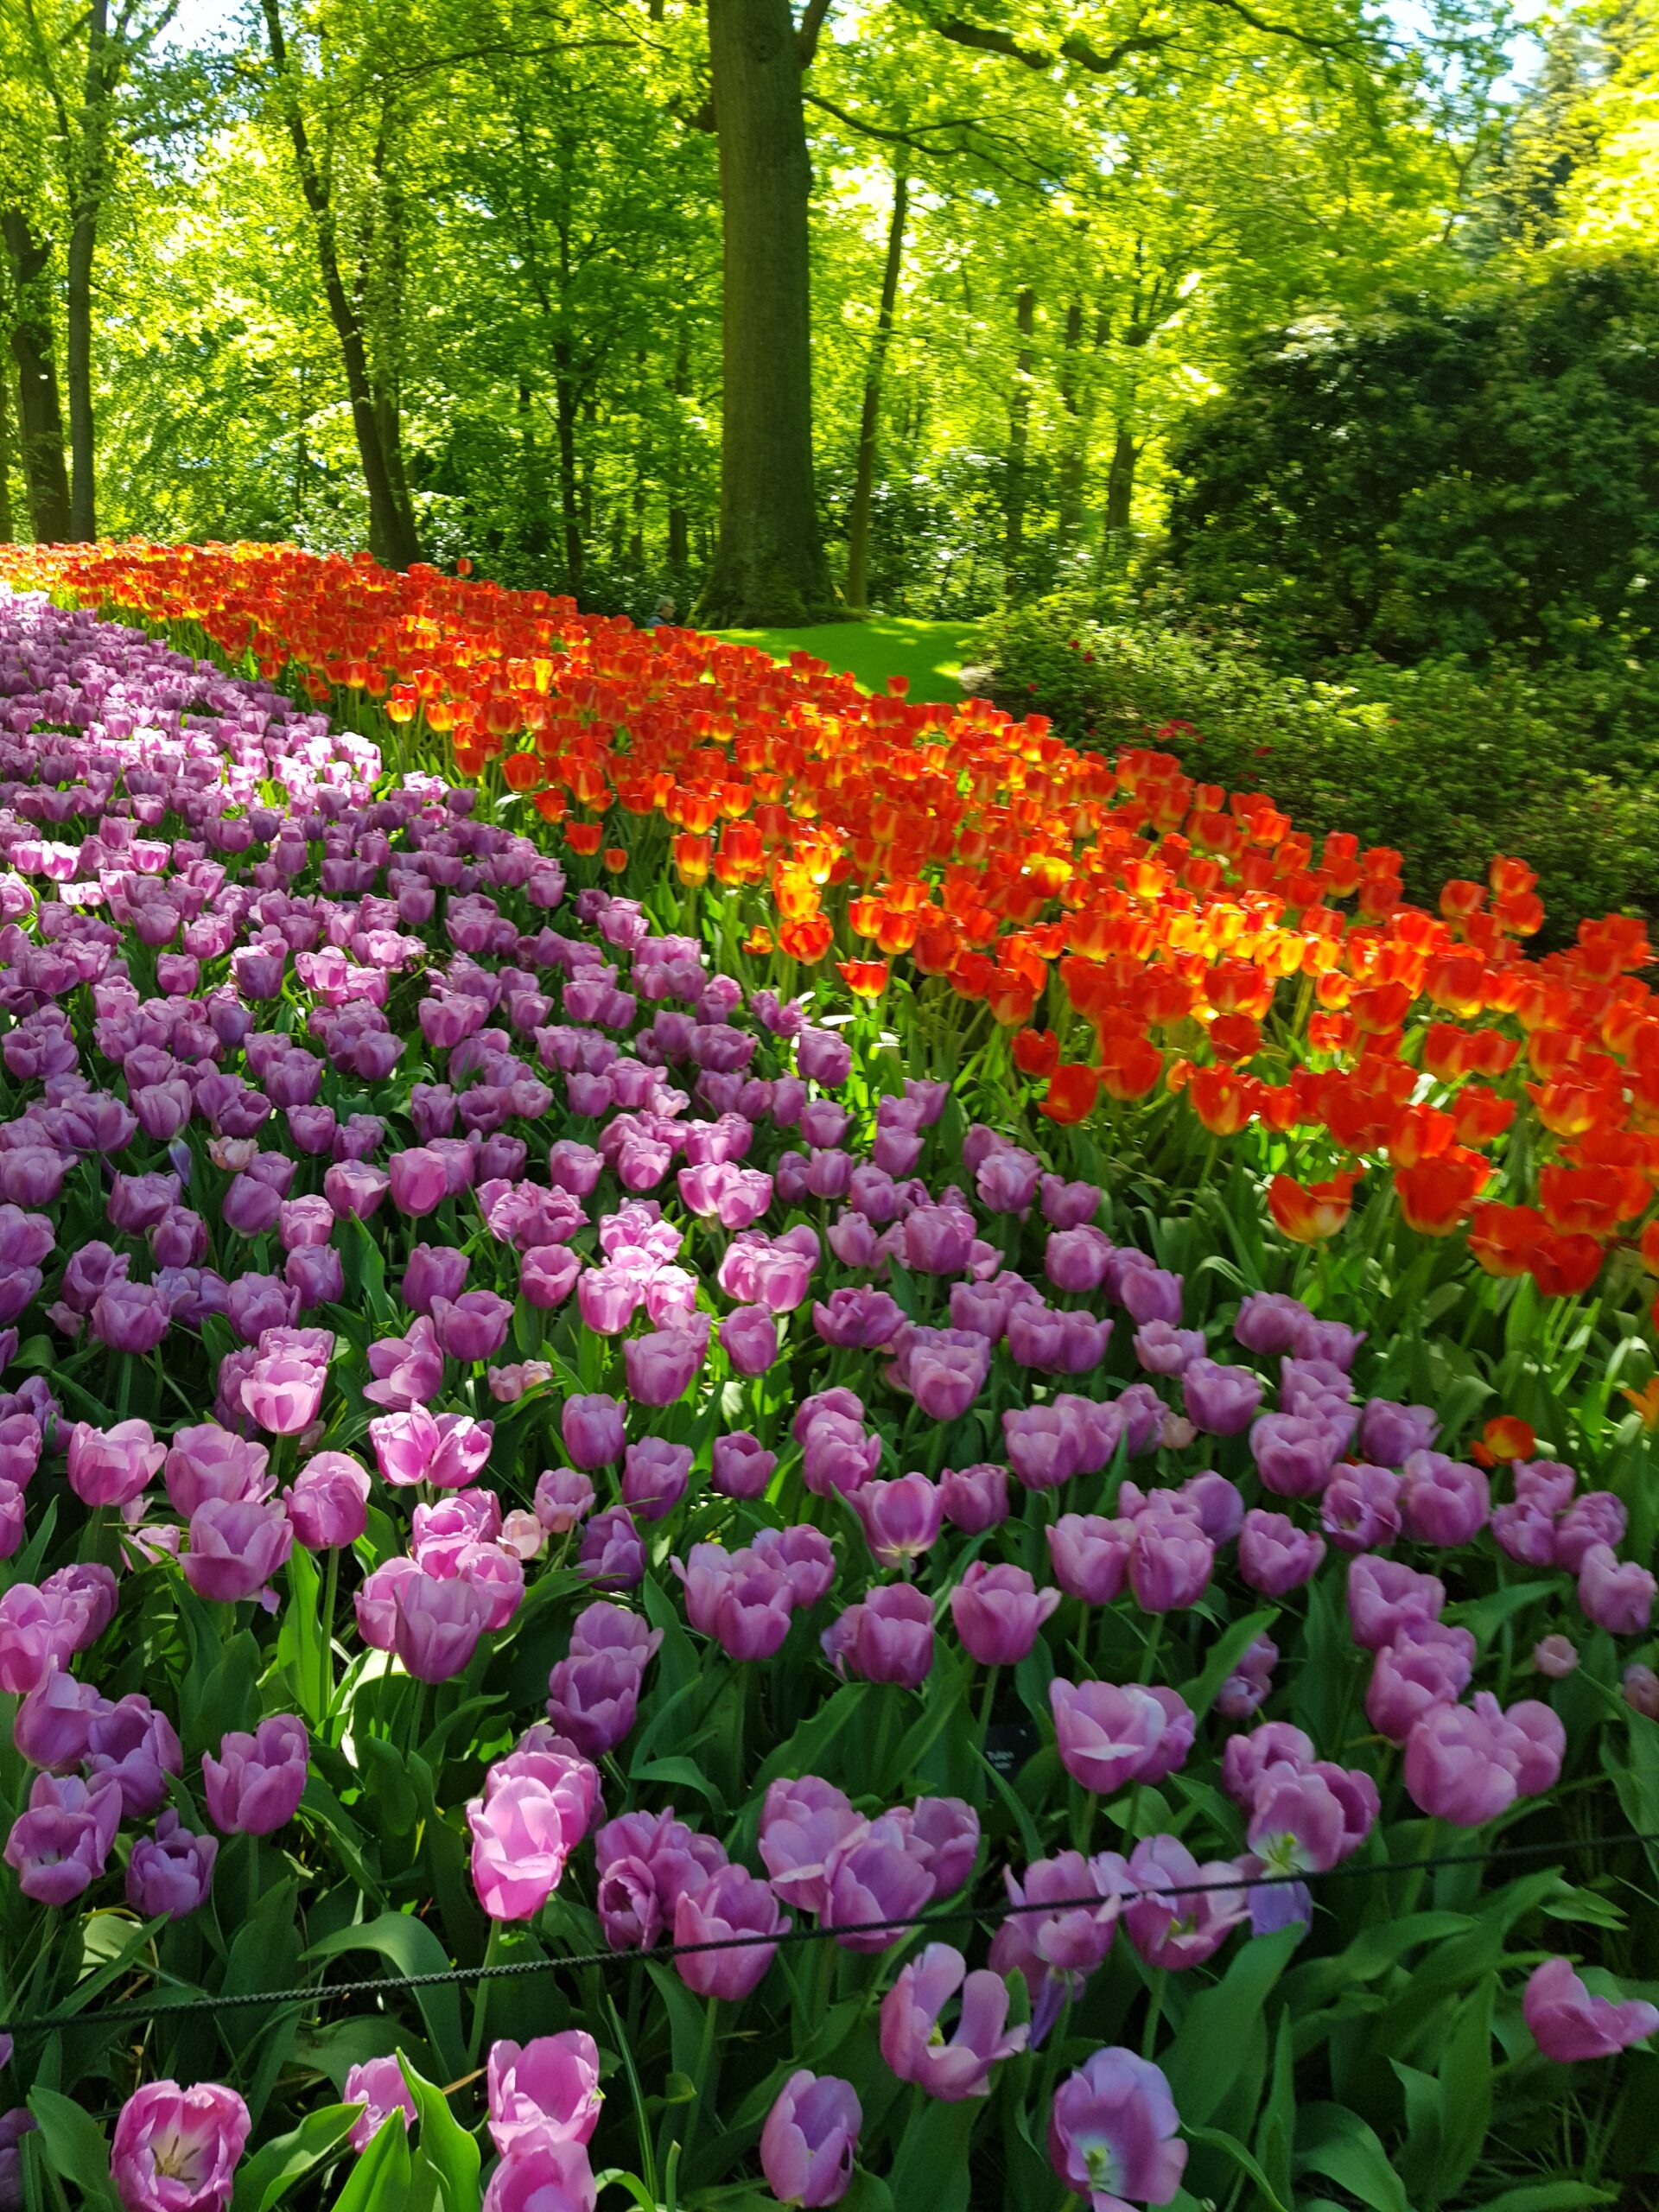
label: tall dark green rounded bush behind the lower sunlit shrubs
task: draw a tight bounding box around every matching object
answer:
[1168,254,1659,668]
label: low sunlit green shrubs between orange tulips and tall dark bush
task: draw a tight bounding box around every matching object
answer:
[973,600,1659,938]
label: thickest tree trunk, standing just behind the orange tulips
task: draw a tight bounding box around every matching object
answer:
[699,0,842,628]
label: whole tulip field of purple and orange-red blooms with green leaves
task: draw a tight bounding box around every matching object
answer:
[0,544,1659,2212]
